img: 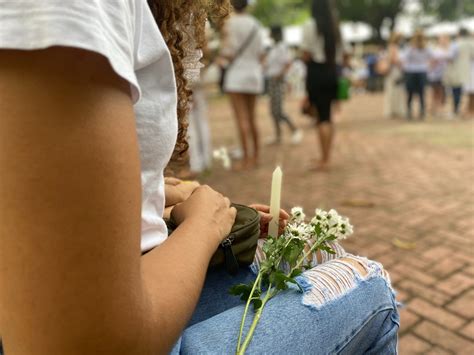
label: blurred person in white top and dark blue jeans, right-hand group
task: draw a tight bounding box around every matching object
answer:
[402,31,432,120]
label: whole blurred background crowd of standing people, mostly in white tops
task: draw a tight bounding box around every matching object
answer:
[184,0,474,178]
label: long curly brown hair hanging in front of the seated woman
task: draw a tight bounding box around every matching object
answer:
[148,0,230,172]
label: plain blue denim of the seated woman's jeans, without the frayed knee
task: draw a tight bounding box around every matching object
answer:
[172,270,399,355]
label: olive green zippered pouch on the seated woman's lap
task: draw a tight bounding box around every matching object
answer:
[167,204,260,275]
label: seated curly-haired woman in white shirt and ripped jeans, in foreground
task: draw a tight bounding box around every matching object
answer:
[0,0,398,355]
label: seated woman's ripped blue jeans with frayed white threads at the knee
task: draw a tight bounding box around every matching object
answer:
[172,245,399,355]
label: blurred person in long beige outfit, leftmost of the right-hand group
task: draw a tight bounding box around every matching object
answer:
[384,33,406,118]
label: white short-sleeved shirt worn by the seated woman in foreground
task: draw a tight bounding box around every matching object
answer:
[0,0,178,251]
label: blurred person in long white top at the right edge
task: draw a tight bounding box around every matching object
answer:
[445,28,474,118]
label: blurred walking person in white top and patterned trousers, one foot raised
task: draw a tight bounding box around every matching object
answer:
[266,26,303,144]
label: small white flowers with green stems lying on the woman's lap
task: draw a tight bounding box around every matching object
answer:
[230,207,353,355]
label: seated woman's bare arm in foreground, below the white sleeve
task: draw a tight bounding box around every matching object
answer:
[0,48,235,355]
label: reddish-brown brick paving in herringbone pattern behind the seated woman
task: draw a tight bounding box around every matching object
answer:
[204,96,474,354]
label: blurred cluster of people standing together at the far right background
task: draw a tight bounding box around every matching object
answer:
[376,29,474,120]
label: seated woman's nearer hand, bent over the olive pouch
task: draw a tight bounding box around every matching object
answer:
[171,185,237,246]
